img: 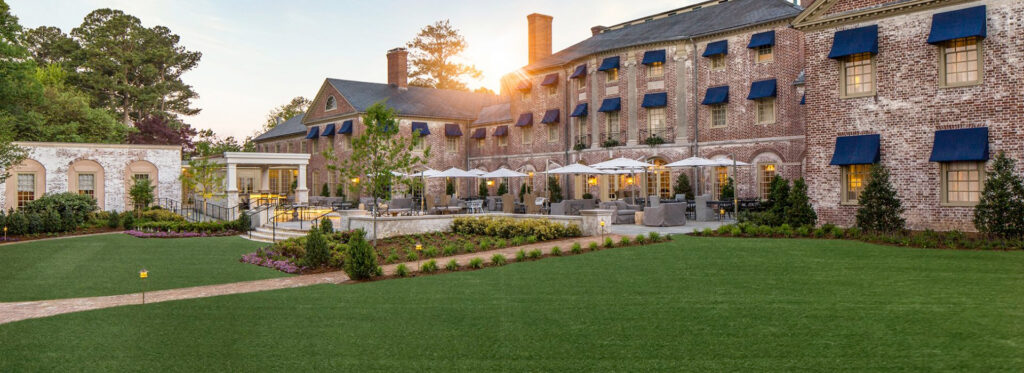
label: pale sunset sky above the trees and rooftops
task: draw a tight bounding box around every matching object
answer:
[7,0,697,138]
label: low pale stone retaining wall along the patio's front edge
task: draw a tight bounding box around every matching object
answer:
[342,210,611,239]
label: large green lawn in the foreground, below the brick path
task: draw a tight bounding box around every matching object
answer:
[0,237,1024,372]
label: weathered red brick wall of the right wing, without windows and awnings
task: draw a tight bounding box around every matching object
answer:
[806,1,1024,231]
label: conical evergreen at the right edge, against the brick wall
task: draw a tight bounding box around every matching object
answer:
[974,152,1024,238]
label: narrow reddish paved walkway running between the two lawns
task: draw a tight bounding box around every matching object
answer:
[0,235,620,324]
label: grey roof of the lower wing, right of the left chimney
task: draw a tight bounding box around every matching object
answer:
[327,79,498,120]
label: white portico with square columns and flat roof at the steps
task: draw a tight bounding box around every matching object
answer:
[210,152,309,211]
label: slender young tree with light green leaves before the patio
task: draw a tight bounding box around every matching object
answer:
[325,102,430,246]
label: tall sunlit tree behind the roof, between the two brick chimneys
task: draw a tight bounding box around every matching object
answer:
[407,19,482,90]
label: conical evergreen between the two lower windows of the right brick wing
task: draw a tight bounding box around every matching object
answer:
[857,163,906,234]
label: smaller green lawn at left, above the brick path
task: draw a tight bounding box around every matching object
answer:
[0,234,288,301]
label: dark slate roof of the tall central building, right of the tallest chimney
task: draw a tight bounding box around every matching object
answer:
[524,0,803,71]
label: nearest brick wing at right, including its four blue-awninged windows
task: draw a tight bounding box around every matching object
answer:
[794,0,1024,231]
